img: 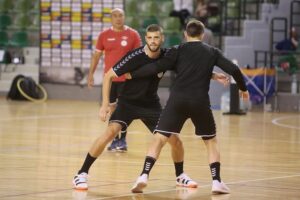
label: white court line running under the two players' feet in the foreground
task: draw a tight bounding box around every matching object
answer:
[88,174,300,200]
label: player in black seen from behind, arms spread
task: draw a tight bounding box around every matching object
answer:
[131,20,249,193]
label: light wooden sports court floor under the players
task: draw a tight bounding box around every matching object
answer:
[0,98,300,200]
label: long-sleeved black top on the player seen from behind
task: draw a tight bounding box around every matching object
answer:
[131,41,247,101]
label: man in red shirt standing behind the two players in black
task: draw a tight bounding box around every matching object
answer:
[88,8,142,152]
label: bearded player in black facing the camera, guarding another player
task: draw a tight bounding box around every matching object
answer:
[73,25,226,190]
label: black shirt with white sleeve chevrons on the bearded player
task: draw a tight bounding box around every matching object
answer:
[112,47,166,106]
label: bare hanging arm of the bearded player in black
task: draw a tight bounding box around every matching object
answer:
[99,69,117,122]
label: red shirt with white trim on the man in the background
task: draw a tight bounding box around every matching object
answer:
[96,26,142,82]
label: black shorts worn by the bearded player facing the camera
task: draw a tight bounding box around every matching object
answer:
[109,100,161,132]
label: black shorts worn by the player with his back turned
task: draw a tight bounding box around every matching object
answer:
[155,98,216,139]
